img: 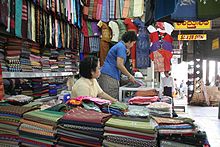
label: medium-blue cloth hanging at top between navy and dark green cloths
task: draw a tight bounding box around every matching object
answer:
[171,0,197,20]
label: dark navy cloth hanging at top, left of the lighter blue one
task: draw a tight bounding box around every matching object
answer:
[154,0,177,20]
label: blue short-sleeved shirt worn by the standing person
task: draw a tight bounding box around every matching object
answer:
[101,41,127,81]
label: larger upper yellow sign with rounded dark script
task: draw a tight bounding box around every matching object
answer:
[174,20,212,30]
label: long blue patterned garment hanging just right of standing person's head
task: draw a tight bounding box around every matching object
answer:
[133,18,151,69]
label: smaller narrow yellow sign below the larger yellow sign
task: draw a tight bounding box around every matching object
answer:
[178,34,207,40]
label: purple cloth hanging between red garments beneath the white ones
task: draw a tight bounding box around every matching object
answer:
[150,40,173,52]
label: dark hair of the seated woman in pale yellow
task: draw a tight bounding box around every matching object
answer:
[79,57,98,79]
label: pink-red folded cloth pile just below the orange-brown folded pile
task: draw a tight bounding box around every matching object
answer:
[128,96,159,105]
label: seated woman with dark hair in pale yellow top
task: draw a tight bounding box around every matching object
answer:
[72,57,117,102]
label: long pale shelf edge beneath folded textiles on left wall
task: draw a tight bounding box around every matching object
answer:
[2,72,77,78]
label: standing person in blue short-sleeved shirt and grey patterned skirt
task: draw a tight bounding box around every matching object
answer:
[99,31,137,98]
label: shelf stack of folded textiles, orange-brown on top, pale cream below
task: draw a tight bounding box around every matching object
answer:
[30,43,42,72]
